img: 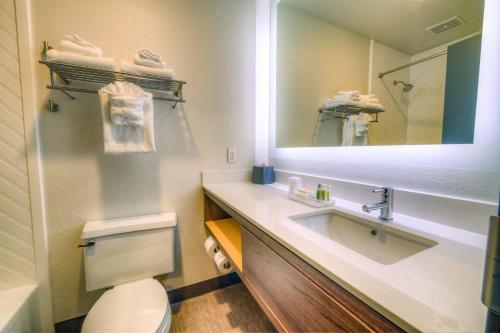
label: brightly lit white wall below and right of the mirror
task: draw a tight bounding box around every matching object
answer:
[270,0,500,203]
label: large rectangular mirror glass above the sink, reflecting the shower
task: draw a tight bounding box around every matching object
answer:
[275,0,483,148]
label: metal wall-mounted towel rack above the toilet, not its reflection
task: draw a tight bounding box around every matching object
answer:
[39,43,186,112]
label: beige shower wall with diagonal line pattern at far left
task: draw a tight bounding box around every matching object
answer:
[0,0,36,290]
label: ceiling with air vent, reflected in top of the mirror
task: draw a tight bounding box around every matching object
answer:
[278,0,484,55]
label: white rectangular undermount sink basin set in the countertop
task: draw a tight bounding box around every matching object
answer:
[290,211,438,265]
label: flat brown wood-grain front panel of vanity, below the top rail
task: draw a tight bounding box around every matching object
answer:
[242,228,371,332]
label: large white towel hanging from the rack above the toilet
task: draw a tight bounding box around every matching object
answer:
[99,82,156,154]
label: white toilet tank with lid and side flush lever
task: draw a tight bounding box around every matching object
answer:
[81,213,177,291]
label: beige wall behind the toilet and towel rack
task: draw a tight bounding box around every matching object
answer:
[32,0,255,321]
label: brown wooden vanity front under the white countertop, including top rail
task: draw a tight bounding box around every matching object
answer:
[205,193,404,332]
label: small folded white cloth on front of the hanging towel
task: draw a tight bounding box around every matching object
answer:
[110,93,144,126]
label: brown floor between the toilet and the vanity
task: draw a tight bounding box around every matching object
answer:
[170,284,275,333]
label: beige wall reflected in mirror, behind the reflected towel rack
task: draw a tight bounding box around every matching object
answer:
[276,4,370,147]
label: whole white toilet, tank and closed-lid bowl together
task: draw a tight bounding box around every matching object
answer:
[80,213,177,333]
